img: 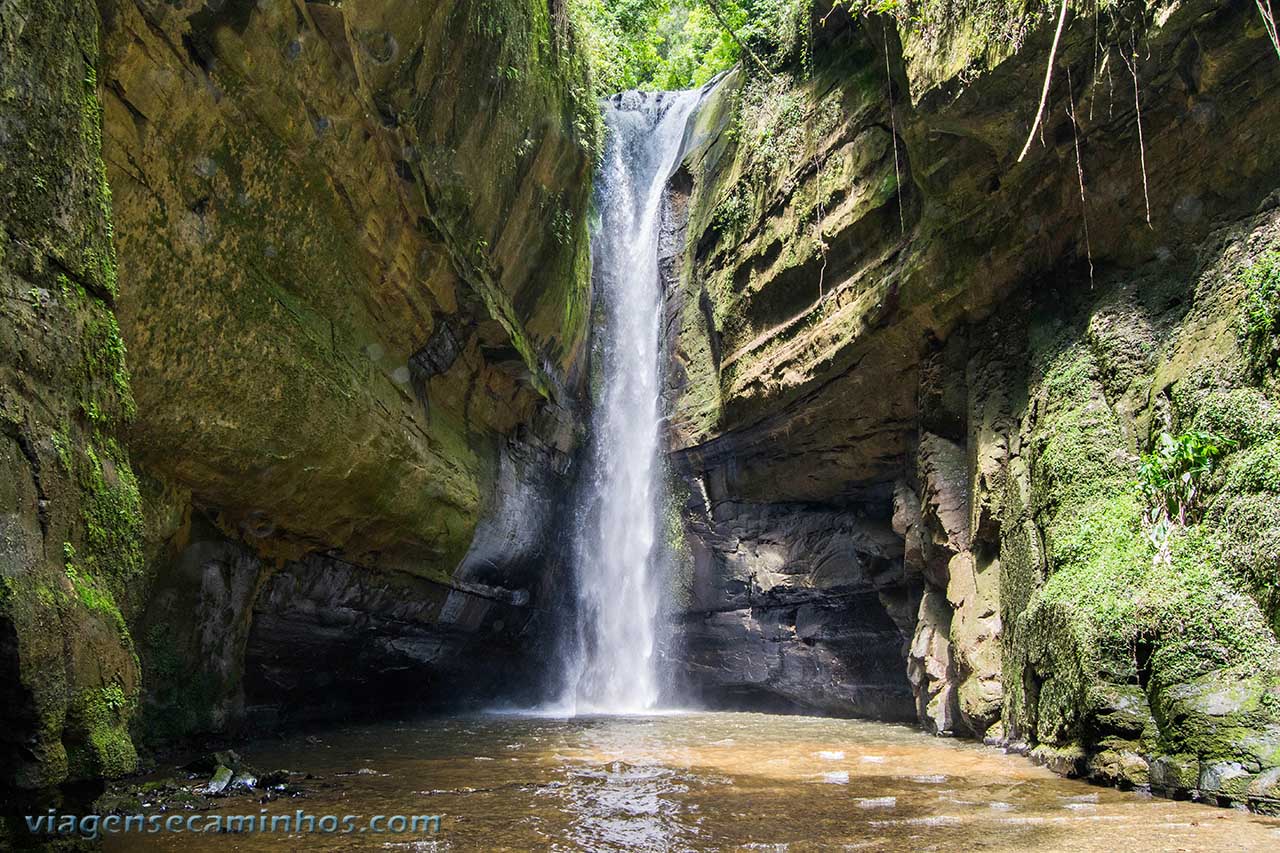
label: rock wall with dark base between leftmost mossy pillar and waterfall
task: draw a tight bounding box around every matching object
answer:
[104,0,595,753]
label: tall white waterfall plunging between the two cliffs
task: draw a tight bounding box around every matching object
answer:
[567,91,700,713]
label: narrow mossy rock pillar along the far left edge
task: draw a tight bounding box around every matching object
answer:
[0,0,142,788]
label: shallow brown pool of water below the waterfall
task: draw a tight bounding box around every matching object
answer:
[106,712,1280,853]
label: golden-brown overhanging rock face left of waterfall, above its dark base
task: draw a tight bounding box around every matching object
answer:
[104,0,595,578]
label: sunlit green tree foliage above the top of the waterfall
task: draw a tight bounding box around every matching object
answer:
[572,0,809,96]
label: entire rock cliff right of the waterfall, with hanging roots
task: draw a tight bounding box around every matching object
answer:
[667,3,1280,808]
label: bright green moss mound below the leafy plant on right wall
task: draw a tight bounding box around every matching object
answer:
[1014,479,1280,743]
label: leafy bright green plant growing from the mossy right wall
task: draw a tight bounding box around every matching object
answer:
[1138,430,1231,537]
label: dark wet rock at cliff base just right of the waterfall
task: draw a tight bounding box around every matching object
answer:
[676,494,914,720]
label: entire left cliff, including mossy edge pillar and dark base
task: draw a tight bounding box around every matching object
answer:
[0,0,598,786]
